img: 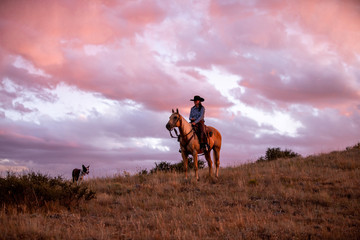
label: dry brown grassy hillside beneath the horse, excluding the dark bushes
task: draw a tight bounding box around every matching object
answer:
[0,147,360,239]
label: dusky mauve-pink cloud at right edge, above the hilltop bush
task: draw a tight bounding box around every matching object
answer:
[238,63,360,108]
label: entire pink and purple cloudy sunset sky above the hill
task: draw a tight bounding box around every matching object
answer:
[0,0,360,177]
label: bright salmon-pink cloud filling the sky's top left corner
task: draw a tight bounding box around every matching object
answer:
[0,1,164,67]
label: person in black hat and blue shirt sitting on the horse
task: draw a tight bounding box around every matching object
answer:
[189,95,209,151]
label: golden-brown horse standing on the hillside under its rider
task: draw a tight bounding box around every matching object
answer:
[166,109,221,180]
